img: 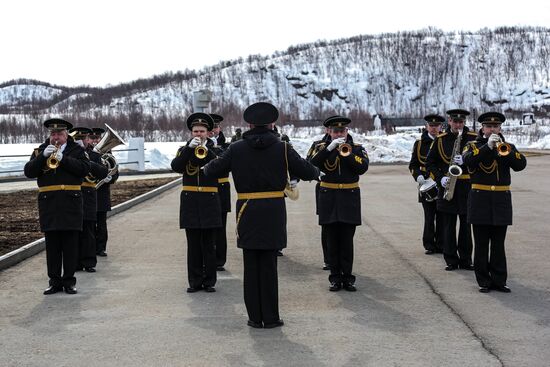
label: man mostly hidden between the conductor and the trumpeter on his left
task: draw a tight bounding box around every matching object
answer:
[210,113,231,271]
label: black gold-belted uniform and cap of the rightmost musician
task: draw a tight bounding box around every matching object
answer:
[464,112,527,292]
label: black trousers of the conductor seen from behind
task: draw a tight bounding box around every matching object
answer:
[243,249,280,324]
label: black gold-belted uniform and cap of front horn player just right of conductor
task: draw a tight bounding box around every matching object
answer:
[311,116,369,291]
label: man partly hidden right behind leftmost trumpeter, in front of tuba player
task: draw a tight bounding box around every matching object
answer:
[69,127,108,273]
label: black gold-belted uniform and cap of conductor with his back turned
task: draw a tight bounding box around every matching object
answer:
[204,102,319,328]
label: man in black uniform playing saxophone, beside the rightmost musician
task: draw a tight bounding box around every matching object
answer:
[426,109,476,271]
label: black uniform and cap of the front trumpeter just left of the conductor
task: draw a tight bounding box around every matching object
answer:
[171,112,222,292]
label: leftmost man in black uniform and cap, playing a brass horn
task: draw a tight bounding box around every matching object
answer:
[25,118,90,294]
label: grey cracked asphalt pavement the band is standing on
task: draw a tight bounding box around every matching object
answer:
[0,156,550,366]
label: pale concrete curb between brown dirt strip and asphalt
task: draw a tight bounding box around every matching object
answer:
[0,178,181,271]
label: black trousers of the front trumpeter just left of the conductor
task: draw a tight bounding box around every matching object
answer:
[185,228,216,288]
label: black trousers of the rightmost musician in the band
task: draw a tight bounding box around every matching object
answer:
[473,224,508,287]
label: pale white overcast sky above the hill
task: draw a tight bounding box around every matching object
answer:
[0,0,550,86]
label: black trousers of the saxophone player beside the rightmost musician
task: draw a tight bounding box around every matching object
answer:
[439,212,472,266]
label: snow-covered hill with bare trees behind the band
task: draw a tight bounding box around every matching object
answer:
[0,27,550,138]
